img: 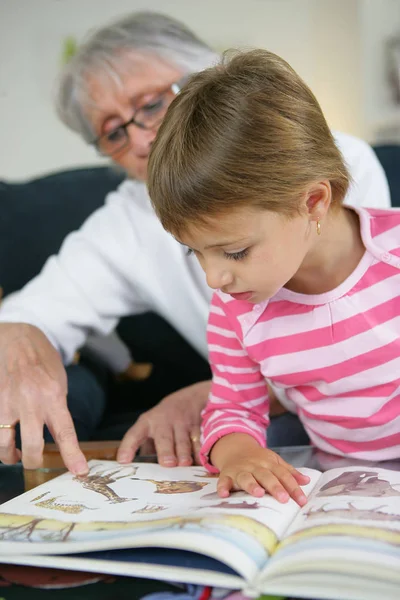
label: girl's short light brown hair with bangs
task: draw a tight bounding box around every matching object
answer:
[148,50,349,234]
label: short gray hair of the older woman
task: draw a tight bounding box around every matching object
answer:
[56,12,219,142]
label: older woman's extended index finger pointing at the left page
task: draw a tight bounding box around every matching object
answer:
[47,407,89,475]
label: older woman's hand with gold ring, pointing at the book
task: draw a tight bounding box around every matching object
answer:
[0,323,88,474]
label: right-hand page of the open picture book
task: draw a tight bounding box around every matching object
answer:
[260,466,400,593]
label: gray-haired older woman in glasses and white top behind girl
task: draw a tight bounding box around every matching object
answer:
[0,13,389,473]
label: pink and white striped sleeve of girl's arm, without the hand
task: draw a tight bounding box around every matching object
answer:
[200,293,269,473]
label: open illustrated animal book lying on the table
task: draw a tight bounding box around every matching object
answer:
[0,460,400,600]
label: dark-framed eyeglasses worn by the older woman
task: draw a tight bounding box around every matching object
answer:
[91,77,187,156]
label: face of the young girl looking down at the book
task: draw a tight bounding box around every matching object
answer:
[179,207,317,304]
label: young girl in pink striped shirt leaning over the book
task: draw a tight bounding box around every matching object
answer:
[149,50,400,505]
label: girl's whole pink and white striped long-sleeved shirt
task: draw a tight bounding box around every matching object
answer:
[202,209,400,471]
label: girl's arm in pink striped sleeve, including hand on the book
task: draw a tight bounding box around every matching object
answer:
[201,294,309,505]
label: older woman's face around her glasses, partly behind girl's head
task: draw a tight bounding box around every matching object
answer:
[86,57,183,181]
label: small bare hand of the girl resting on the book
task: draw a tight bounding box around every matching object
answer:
[211,433,310,506]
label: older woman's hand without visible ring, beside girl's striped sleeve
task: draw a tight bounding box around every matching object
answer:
[117,381,211,467]
